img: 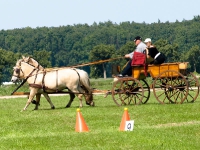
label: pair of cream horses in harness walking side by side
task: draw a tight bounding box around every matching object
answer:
[11,56,94,111]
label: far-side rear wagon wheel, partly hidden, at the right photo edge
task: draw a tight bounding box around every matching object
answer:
[186,72,199,102]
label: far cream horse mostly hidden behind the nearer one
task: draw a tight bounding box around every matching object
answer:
[22,56,94,107]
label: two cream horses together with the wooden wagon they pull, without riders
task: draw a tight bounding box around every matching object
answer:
[12,57,199,110]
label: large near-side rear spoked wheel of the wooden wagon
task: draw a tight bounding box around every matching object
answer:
[153,70,189,104]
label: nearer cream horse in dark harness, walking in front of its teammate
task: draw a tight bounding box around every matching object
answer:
[11,59,94,110]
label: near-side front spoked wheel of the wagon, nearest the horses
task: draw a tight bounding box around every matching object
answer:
[112,77,144,106]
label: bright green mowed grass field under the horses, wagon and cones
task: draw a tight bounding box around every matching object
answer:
[0,81,200,150]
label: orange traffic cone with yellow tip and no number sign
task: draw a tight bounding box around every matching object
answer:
[75,108,89,132]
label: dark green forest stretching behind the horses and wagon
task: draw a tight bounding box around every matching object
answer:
[0,16,200,82]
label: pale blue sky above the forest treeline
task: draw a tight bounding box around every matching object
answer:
[0,0,200,30]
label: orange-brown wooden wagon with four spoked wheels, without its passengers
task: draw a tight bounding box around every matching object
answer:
[111,62,199,106]
